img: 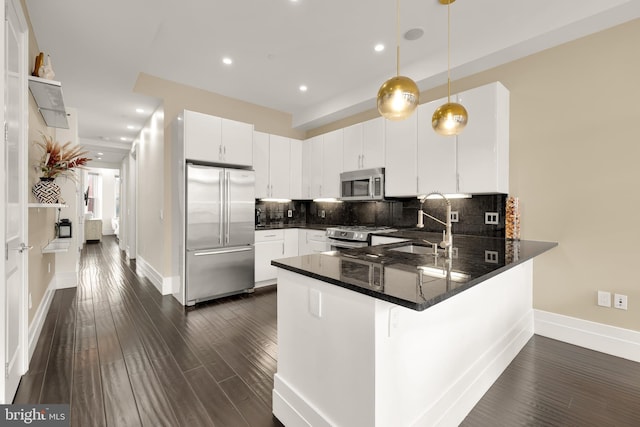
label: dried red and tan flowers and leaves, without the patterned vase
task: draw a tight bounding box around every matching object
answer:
[35,134,91,179]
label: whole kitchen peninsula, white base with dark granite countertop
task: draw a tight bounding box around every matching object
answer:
[272,231,556,426]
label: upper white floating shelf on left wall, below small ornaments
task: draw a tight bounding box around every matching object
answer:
[29,76,69,129]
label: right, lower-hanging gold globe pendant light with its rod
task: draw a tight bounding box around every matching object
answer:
[431,0,469,136]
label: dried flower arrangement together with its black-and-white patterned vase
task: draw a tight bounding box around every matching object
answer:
[32,134,91,203]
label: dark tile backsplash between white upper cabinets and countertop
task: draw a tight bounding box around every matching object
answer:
[256,194,507,237]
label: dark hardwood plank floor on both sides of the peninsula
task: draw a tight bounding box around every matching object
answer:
[14,237,640,427]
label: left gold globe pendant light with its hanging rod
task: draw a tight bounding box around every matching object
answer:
[377,0,420,121]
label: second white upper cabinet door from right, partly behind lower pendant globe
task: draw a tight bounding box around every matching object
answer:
[418,97,458,194]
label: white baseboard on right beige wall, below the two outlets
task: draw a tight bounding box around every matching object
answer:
[534,310,640,362]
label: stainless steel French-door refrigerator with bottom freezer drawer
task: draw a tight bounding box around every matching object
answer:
[185,163,255,305]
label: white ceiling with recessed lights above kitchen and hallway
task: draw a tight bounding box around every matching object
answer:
[26,0,640,162]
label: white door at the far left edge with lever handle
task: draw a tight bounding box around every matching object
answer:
[0,0,28,403]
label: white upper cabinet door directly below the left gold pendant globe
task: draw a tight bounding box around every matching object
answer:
[385,112,418,197]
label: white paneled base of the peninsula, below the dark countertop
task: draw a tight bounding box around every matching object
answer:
[273,260,533,427]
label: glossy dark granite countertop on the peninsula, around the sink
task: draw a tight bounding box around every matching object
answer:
[271,229,558,311]
